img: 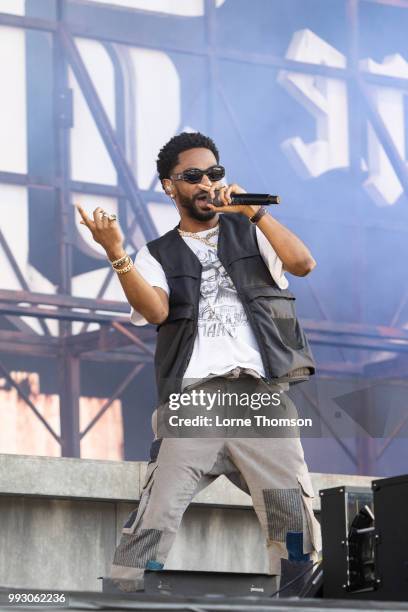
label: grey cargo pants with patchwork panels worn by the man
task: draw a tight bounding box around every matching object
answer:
[111,377,321,584]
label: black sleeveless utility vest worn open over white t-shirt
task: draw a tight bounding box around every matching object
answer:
[147,214,315,402]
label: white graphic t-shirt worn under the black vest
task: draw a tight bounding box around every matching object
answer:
[131,222,288,387]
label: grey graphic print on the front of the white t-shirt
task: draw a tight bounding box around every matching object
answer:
[195,249,248,338]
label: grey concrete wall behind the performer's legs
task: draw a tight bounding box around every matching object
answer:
[0,455,371,591]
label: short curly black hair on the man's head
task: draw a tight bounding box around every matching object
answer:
[156,132,220,181]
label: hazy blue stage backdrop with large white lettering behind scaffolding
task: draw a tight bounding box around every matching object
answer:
[0,0,408,474]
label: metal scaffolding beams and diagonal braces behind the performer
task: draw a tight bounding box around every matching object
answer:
[0,0,408,463]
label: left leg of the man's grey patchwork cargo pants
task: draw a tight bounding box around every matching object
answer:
[111,438,223,580]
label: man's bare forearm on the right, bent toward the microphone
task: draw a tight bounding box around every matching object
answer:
[245,215,316,276]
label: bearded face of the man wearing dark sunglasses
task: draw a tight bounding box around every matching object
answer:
[167,148,221,221]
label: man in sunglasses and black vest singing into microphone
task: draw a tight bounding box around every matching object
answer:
[78,133,321,590]
